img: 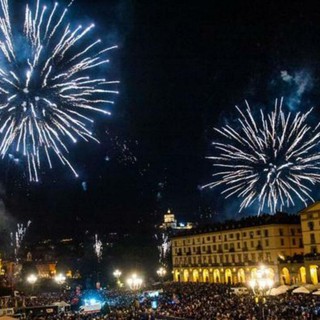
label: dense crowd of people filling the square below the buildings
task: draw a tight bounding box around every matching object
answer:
[0,283,320,320]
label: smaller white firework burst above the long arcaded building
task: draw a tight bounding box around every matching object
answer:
[203,99,320,213]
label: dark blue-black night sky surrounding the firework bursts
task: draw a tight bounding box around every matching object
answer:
[1,0,320,235]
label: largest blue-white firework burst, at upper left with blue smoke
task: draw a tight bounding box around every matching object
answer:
[0,0,119,181]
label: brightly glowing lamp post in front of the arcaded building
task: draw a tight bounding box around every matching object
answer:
[249,265,274,320]
